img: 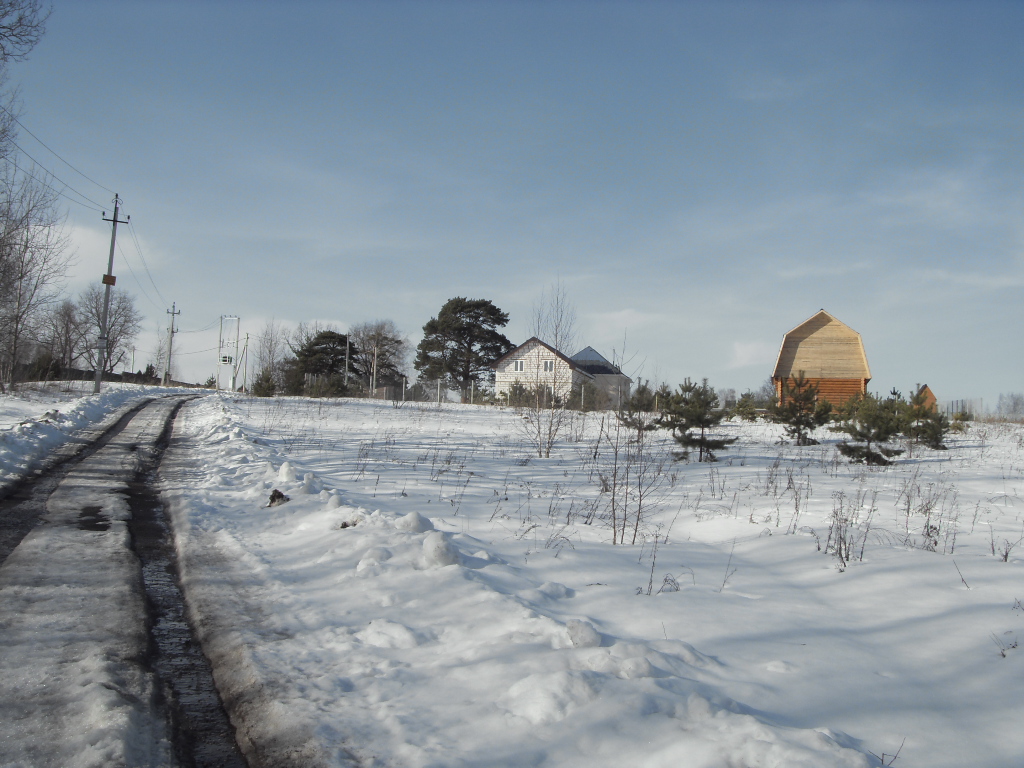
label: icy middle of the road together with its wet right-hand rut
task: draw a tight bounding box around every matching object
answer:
[0,397,246,768]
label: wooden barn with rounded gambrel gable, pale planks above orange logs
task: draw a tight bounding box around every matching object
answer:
[771,309,871,406]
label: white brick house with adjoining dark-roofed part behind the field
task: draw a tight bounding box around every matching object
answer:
[490,336,632,407]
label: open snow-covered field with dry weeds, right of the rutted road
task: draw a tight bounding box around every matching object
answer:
[162,396,1024,768]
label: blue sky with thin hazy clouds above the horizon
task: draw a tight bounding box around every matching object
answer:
[12,0,1024,402]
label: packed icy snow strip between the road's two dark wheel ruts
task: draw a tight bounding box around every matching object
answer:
[0,399,188,768]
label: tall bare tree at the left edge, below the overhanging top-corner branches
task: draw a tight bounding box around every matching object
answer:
[0,167,71,387]
